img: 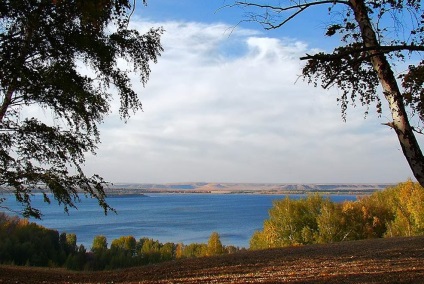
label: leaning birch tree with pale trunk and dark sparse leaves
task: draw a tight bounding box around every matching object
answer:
[234,0,424,186]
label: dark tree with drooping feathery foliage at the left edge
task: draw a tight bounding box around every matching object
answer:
[0,0,162,218]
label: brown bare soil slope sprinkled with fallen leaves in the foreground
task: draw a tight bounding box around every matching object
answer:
[0,237,424,284]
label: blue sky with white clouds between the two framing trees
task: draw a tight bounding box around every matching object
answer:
[85,0,420,183]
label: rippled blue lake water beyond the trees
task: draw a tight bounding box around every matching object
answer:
[0,194,356,248]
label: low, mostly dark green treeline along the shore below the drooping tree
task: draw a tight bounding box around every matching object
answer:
[0,213,240,271]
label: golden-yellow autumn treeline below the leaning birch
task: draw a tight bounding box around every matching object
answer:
[250,180,424,249]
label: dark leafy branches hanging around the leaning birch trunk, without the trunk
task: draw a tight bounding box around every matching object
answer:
[302,0,424,121]
